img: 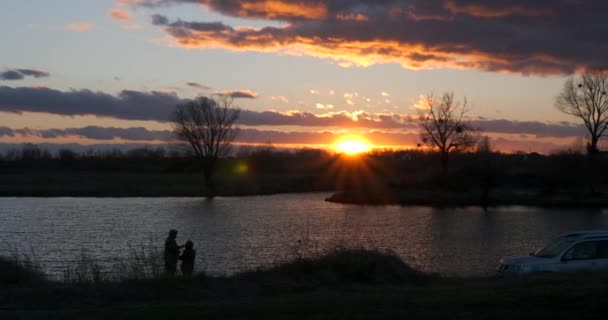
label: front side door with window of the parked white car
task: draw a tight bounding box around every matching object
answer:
[560,241,603,272]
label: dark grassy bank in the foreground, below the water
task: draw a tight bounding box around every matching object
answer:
[0,249,608,319]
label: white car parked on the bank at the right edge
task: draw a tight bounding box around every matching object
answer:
[496,230,608,275]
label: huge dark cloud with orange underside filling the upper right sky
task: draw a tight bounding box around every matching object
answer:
[142,0,608,75]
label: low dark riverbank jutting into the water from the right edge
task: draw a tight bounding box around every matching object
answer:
[326,188,608,208]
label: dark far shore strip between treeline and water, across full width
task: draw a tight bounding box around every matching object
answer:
[0,172,608,209]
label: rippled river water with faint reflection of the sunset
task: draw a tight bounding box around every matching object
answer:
[0,193,608,275]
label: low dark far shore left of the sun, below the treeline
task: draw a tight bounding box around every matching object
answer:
[0,172,335,198]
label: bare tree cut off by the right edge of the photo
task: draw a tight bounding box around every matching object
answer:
[555,70,608,156]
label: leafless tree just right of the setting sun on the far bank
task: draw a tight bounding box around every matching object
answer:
[415,93,476,170]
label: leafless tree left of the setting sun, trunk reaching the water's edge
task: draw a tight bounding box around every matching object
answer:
[173,96,240,195]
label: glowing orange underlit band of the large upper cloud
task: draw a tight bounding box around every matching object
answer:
[154,16,576,74]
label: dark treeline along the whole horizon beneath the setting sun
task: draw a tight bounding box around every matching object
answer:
[0,145,608,194]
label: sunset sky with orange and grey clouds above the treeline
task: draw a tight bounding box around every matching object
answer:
[0,0,608,153]
